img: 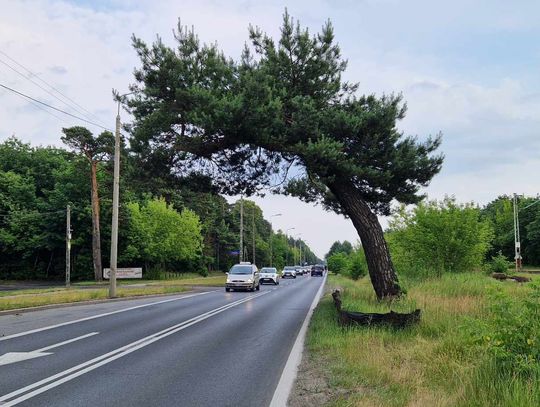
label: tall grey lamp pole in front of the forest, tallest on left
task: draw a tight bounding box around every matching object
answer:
[109,92,134,298]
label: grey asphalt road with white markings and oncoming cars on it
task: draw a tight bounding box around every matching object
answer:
[0,276,323,407]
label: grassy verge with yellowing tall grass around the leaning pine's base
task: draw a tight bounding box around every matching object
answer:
[307,273,540,407]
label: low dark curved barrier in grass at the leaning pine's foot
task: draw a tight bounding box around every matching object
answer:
[332,290,421,328]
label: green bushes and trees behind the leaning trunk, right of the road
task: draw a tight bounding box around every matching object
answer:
[326,195,540,279]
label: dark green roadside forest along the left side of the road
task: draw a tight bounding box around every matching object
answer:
[0,136,319,280]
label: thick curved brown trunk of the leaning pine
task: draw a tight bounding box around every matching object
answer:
[329,182,402,299]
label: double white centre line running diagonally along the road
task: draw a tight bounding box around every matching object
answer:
[0,291,269,407]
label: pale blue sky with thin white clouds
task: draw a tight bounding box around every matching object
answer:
[0,0,540,256]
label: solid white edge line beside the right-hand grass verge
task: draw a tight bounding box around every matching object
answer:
[270,274,327,407]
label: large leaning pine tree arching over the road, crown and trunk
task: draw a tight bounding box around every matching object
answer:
[124,13,443,299]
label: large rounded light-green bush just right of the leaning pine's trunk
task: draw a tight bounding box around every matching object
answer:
[387,198,493,277]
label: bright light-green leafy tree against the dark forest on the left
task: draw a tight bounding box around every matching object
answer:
[124,199,202,272]
